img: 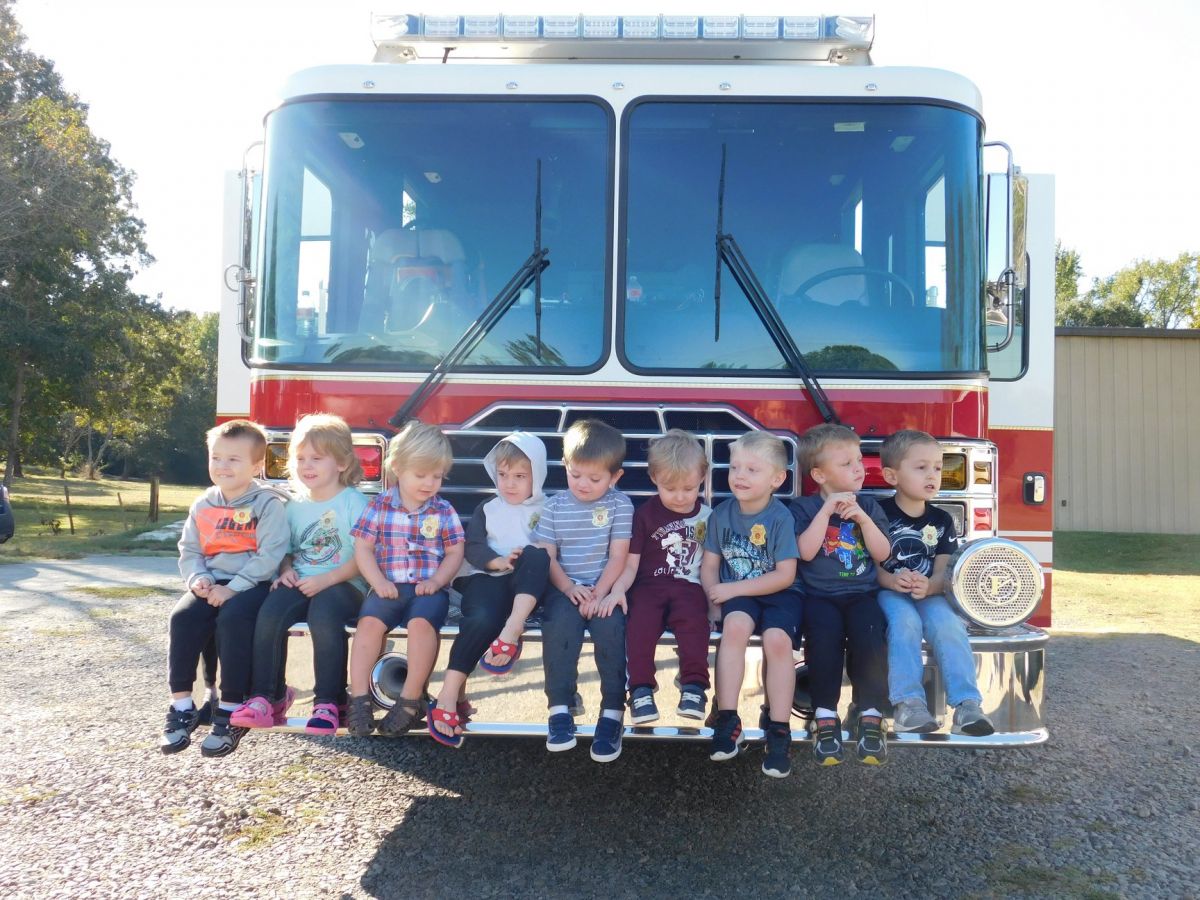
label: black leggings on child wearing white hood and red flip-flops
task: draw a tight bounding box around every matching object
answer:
[446,545,550,674]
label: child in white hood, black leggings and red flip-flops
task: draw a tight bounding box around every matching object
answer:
[428,431,550,746]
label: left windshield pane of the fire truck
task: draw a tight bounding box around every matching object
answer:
[252,97,613,371]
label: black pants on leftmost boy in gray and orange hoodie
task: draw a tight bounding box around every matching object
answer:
[167,581,271,703]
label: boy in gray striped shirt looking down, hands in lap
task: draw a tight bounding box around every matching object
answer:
[533,419,634,762]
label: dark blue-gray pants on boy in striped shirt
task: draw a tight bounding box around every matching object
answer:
[541,588,625,709]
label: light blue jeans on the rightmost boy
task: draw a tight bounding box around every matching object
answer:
[878,590,983,707]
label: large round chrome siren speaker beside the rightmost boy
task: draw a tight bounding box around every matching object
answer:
[946,538,1045,628]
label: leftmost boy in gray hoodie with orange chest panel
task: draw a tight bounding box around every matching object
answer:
[160,419,290,756]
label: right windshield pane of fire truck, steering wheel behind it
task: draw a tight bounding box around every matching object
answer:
[618,100,984,374]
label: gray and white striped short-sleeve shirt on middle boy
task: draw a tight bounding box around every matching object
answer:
[533,487,634,587]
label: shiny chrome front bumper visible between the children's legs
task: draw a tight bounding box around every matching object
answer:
[271,624,1049,749]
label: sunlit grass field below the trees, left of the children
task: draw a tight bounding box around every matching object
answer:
[0,469,196,563]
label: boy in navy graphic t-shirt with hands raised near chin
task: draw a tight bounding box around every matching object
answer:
[792,424,890,766]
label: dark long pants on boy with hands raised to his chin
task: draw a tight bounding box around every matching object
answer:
[804,594,888,709]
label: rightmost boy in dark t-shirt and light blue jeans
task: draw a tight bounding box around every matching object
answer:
[880,431,995,737]
